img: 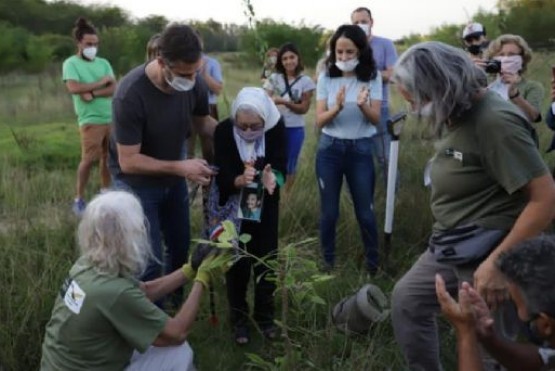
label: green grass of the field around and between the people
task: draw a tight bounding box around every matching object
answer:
[0,50,555,371]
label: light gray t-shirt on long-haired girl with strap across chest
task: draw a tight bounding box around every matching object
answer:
[264,73,316,128]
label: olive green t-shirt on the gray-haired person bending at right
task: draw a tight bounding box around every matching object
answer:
[430,92,548,231]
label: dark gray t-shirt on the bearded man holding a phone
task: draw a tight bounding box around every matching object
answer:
[108,64,208,186]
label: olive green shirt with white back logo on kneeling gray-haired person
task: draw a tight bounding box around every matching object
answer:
[40,258,168,371]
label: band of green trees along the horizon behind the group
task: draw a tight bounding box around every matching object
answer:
[0,0,555,75]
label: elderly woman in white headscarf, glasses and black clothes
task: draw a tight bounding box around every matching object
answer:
[214,87,286,344]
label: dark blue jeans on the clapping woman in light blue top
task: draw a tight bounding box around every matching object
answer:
[316,133,378,270]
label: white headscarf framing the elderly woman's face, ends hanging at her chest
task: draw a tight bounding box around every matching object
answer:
[231,87,281,163]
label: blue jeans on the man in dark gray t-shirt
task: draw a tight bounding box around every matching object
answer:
[114,179,190,281]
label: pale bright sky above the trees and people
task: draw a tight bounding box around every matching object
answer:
[68,0,497,39]
